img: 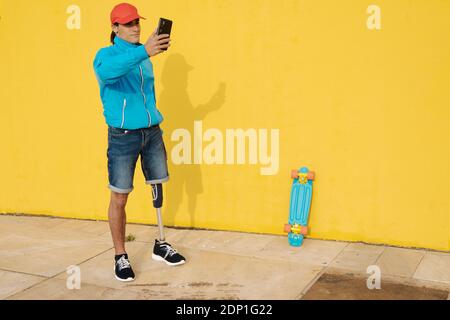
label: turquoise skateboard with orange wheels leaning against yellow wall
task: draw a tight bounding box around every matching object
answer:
[284,167,315,247]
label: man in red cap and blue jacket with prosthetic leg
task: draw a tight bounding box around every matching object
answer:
[94,3,185,281]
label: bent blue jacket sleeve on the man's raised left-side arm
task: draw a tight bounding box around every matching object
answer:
[94,45,149,84]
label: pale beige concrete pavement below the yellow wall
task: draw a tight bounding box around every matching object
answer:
[0,215,450,300]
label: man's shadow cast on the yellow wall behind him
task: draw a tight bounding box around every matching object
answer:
[157,54,226,227]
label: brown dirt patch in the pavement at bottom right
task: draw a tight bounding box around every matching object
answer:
[302,273,449,300]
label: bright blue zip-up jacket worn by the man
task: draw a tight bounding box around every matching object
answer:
[94,37,163,129]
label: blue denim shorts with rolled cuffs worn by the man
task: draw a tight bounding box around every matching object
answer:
[107,125,169,193]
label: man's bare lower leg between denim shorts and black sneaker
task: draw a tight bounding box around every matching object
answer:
[108,191,128,255]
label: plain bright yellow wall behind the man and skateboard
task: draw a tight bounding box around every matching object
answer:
[0,0,450,250]
